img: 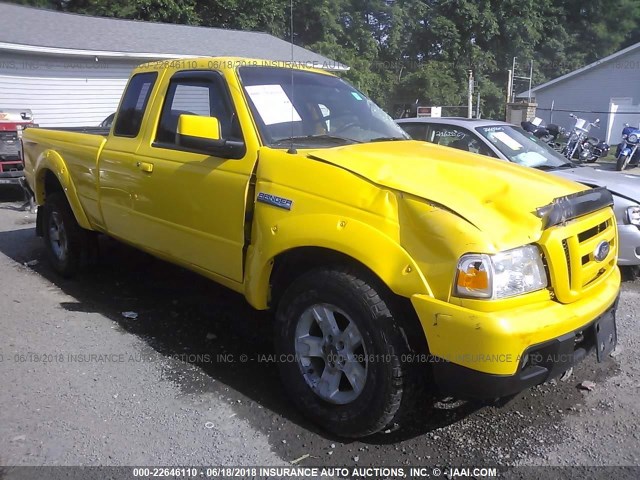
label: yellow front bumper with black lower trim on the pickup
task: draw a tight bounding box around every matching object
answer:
[412,268,620,398]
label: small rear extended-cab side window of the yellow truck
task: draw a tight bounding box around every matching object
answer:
[113,72,158,137]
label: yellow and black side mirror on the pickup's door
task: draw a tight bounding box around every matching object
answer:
[176,113,245,159]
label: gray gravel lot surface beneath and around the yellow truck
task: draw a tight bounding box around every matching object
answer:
[0,190,640,478]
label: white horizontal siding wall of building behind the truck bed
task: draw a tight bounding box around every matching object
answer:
[0,51,143,127]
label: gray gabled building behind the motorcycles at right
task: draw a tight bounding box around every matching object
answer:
[533,49,640,144]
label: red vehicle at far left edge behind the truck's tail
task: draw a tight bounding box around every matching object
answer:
[0,109,33,185]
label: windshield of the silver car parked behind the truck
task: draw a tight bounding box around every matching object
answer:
[476,125,573,170]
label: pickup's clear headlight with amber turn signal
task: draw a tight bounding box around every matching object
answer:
[455,245,548,299]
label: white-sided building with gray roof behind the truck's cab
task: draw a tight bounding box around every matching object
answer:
[0,3,347,127]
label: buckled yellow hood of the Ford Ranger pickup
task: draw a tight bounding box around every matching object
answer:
[307,140,587,250]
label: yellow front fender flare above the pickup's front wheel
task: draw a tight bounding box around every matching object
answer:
[245,214,432,309]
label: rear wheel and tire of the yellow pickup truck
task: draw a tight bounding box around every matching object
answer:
[43,192,84,278]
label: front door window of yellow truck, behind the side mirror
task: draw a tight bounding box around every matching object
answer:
[156,71,242,148]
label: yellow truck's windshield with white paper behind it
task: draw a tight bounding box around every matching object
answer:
[239,67,409,148]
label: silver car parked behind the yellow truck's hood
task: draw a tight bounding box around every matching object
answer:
[396,118,640,273]
